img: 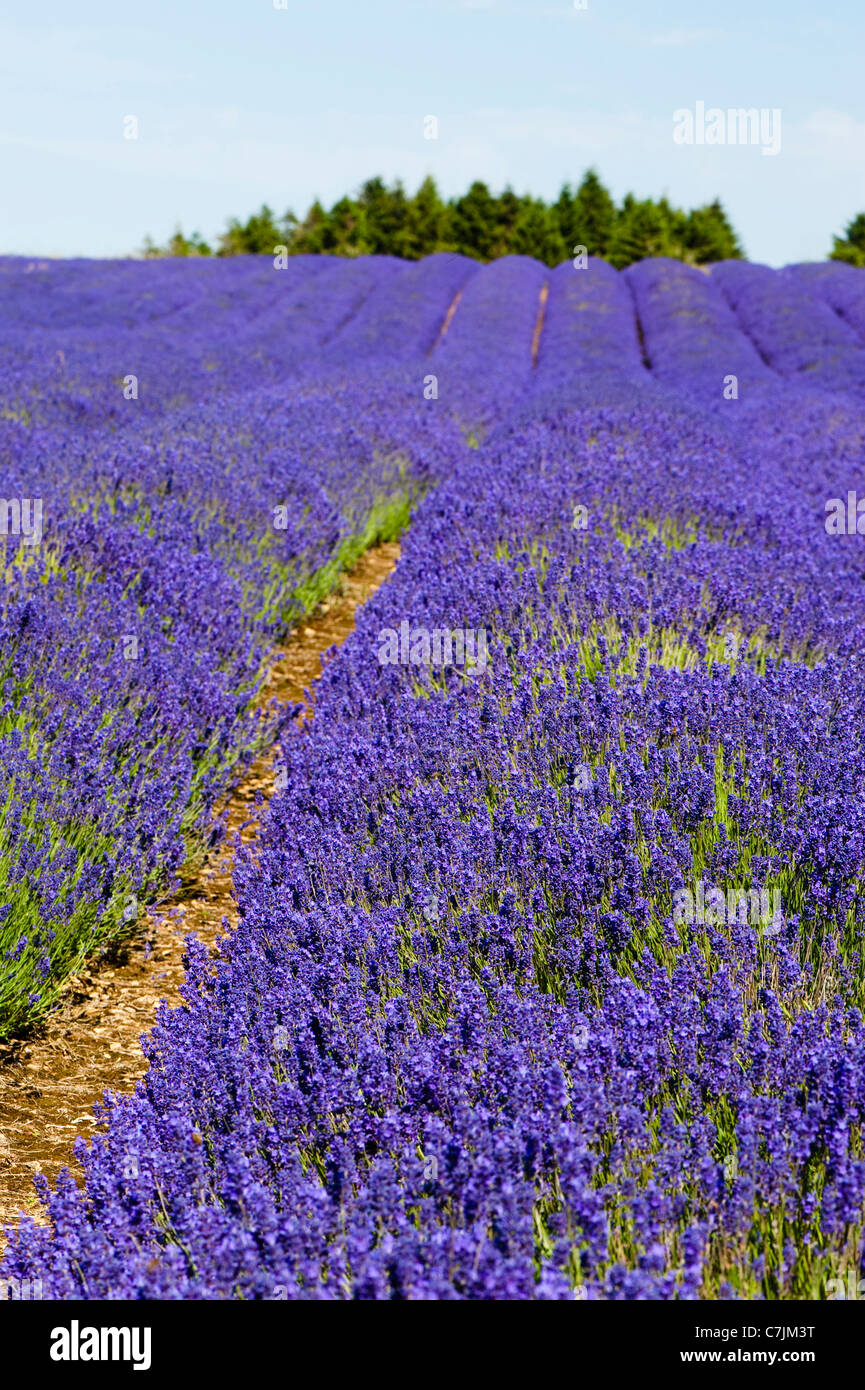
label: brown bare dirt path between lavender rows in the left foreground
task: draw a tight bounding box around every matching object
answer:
[0,542,399,1250]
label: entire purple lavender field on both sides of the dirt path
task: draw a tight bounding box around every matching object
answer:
[0,253,865,1301]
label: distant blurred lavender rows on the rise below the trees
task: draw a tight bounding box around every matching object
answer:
[0,254,865,439]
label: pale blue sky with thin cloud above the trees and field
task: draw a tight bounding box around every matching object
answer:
[0,0,865,265]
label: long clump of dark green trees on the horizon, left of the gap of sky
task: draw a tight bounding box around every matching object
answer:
[142,170,745,270]
